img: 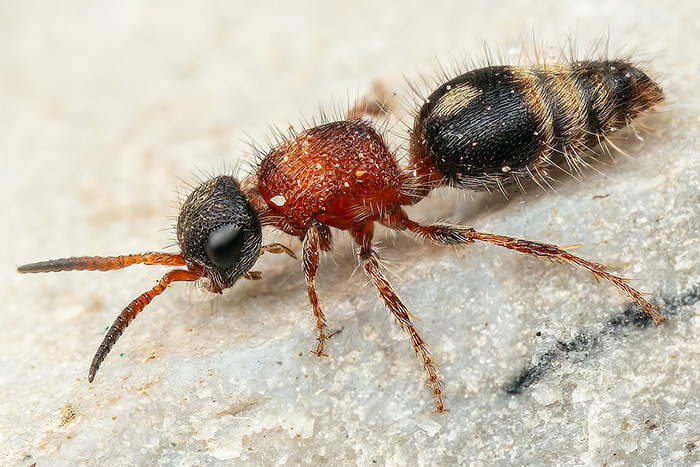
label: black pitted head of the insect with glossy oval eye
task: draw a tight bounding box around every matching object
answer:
[177,175,262,293]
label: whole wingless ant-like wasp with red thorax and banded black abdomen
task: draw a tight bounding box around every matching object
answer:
[18,52,665,412]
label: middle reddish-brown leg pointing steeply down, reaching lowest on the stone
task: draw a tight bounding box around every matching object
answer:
[355,224,447,412]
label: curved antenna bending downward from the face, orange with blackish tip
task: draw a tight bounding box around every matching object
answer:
[88,269,202,383]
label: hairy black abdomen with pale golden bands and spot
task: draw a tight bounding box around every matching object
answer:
[411,61,663,189]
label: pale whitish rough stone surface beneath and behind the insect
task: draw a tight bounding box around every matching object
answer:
[0,0,700,466]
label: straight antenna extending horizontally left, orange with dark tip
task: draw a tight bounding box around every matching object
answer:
[17,251,185,274]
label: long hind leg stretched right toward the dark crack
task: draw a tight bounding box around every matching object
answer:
[403,218,666,326]
